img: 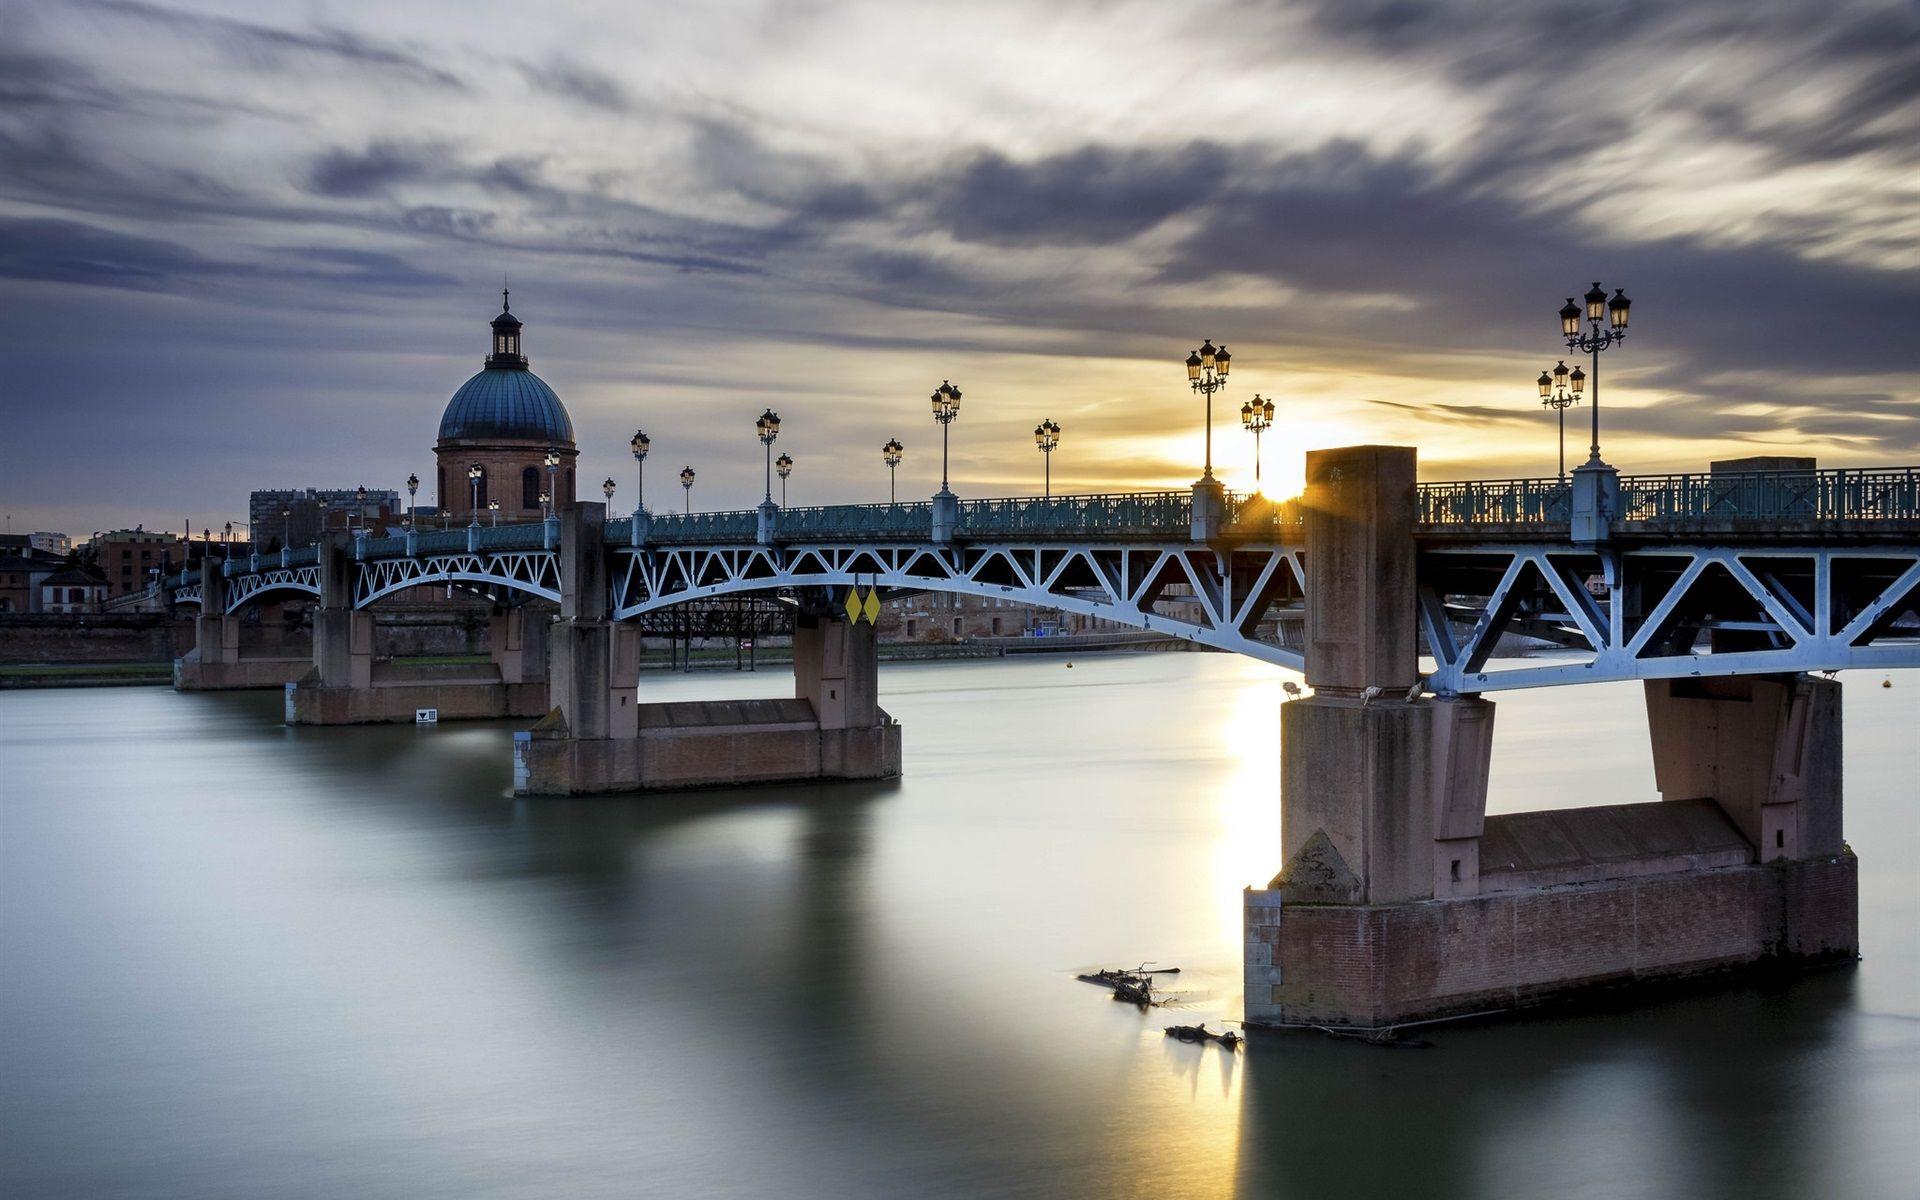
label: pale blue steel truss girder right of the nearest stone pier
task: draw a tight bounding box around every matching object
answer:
[1419,543,1920,695]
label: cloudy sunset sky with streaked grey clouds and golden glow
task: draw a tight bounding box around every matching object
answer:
[0,0,1920,534]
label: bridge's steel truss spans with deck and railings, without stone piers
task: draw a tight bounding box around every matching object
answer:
[159,468,1920,695]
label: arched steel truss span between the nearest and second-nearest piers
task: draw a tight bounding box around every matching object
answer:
[612,541,1306,670]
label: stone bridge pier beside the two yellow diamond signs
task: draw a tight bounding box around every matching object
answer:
[513,503,900,795]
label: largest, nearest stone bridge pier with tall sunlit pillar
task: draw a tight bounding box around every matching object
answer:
[1244,445,1857,1027]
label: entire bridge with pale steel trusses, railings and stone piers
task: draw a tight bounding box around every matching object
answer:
[159,447,1920,1027]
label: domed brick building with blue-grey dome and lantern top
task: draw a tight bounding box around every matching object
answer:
[434,290,580,524]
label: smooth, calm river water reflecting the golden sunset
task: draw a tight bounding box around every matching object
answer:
[0,655,1920,1198]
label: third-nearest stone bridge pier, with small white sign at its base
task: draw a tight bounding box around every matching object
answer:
[286,532,547,726]
